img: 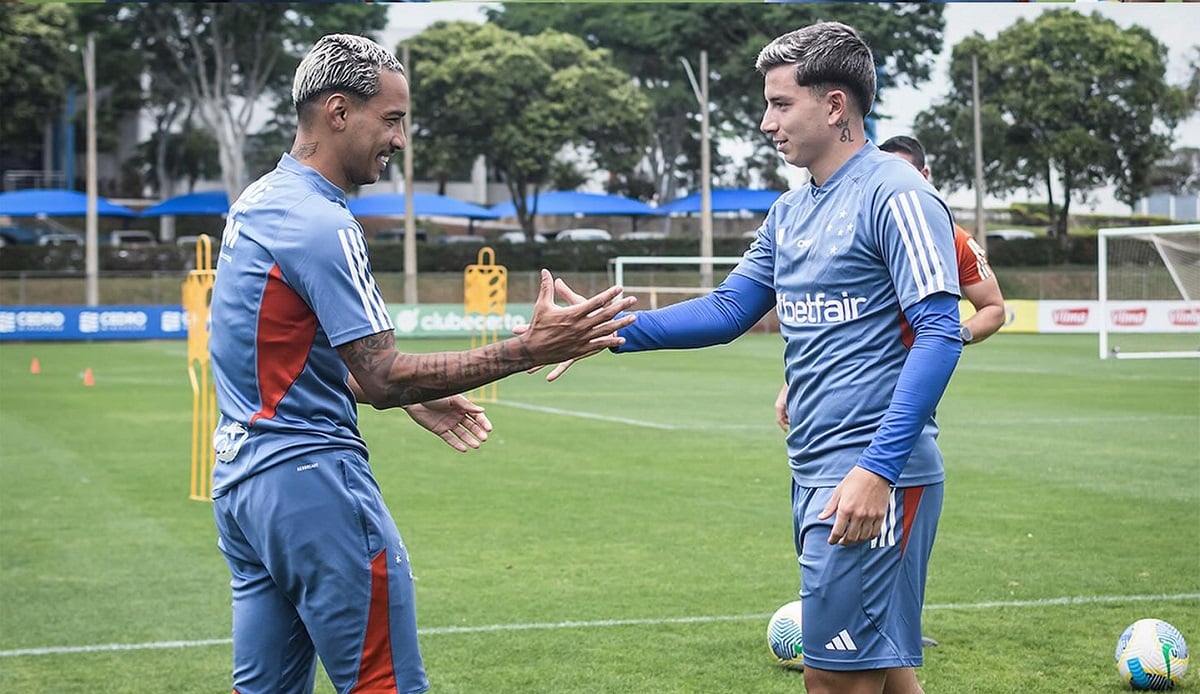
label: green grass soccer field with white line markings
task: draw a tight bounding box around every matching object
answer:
[0,335,1200,694]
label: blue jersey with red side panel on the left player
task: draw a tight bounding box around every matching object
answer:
[209,154,392,497]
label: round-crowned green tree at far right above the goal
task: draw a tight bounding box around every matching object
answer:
[916,10,1188,235]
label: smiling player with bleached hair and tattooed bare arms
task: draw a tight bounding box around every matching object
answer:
[210,35,632,694]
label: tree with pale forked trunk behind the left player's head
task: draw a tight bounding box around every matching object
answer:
[78,2,386,198]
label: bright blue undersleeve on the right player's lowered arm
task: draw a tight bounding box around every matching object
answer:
[858,293,962,484]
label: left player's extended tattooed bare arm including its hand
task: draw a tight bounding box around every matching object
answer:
[337,270,636,409]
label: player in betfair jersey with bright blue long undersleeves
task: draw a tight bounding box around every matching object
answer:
[548,22,962,694]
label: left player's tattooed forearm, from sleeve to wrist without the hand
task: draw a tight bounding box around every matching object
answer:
[338,331,535,409]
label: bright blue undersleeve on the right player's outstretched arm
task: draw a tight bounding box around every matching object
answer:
[614,274,775,352]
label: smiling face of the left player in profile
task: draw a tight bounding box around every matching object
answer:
[340,70,408,185]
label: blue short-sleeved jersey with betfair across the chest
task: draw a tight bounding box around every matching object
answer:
[733,142,959,486]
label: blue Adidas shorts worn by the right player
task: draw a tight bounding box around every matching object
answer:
[792,483,943,671]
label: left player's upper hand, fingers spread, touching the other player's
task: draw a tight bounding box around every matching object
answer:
[514,270,637,372]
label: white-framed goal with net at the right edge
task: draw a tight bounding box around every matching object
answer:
[1097,223,1200,359]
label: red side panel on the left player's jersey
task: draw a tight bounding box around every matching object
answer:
[250,265,317,426]
